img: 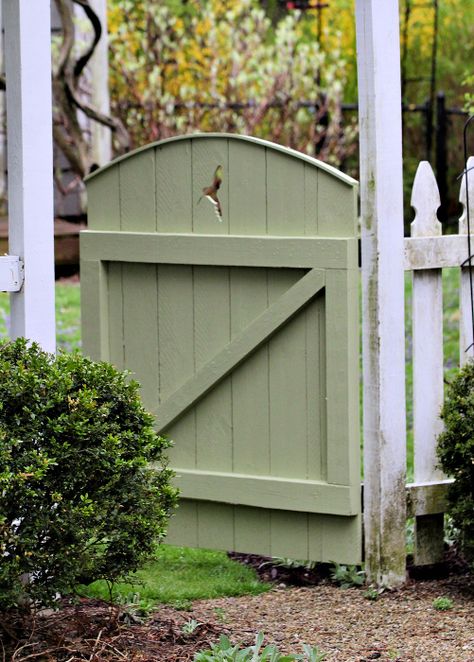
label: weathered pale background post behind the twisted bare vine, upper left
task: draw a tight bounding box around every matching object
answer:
[90,0,112,166]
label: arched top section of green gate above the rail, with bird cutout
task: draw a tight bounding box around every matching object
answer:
[86,133,357,237]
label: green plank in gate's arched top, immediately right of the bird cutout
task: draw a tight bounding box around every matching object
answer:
[229,140,267,235]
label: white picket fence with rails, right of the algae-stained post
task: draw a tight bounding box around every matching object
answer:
[404,157,474,565]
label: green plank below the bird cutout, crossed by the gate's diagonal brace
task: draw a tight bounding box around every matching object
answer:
[194,267,232,471]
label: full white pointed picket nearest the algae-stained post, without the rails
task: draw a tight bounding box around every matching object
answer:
[411,161,445,565]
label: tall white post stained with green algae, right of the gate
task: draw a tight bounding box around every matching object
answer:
[356,0,406,586]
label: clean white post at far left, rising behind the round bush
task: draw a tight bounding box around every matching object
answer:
[3,0,56,352]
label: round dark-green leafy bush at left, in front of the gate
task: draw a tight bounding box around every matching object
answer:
[0,339,176,609]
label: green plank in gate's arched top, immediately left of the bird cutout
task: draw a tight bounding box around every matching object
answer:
[155,141,196,232]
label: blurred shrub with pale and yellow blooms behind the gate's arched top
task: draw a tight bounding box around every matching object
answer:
[108,0,354,164]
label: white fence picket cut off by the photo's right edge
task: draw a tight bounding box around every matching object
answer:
[458,156,474,365]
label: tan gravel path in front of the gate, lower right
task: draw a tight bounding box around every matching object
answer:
[187,576,474,662]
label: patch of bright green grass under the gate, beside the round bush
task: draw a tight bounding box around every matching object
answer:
[79,545,271,609]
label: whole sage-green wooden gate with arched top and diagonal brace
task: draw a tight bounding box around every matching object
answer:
[81,134,361,563]
